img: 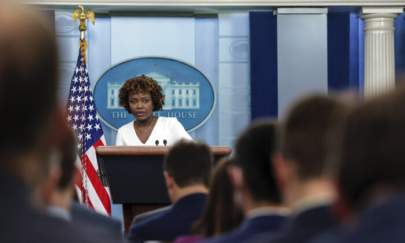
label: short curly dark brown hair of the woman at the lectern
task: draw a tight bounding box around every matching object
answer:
[119,75,165,113]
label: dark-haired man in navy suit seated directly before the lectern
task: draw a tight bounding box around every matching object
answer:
[128,141,213,242]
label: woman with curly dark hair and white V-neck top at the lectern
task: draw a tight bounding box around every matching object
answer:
[116,75,192,146]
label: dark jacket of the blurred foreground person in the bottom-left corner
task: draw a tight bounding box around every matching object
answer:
[0,172,117,243]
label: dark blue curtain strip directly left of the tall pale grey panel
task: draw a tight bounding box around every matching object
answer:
[249,11,278,120]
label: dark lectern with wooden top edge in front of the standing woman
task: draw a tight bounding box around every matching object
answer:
[96,146,231,232]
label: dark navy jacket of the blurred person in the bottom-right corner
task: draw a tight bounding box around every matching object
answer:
[313,194,405,243]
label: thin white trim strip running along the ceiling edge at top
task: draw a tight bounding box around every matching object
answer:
[22,0,405,7]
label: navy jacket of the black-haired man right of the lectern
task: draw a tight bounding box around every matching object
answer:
[204,215,286,243]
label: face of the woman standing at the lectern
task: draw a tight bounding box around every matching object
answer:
[128,93,153,121]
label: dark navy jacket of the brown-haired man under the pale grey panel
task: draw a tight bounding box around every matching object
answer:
[255,206,338,243]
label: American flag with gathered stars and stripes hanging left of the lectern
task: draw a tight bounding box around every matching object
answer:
[67,50,111,215]
